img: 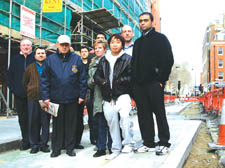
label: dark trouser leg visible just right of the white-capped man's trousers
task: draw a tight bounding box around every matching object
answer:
[75,103,85,145]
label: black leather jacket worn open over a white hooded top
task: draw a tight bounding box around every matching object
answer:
[94,53,131,102]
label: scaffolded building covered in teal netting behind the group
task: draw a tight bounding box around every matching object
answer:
[0,0,152,115]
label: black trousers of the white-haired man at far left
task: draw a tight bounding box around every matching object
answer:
[15,96,30,146]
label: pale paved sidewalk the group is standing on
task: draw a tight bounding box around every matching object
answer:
[0,103,201,168]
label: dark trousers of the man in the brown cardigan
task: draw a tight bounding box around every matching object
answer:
[28,100,50,148]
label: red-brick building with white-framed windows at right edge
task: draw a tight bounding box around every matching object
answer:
[201,14,225,91]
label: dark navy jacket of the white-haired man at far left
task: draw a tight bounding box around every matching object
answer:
[7,53,35,98]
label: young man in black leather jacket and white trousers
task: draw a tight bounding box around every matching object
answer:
[94,34,132,160]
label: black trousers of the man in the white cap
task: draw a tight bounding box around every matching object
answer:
[52,102,79,151]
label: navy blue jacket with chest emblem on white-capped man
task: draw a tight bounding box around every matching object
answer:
[40,50,87,104]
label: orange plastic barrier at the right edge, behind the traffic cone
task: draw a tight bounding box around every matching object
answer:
[200,88,225,115]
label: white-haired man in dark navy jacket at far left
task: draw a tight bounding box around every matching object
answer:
[7,39,35,150]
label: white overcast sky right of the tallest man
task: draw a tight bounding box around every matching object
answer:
[159,0,225,79]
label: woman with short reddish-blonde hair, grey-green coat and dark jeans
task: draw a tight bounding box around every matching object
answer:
[88,40,112,157]
